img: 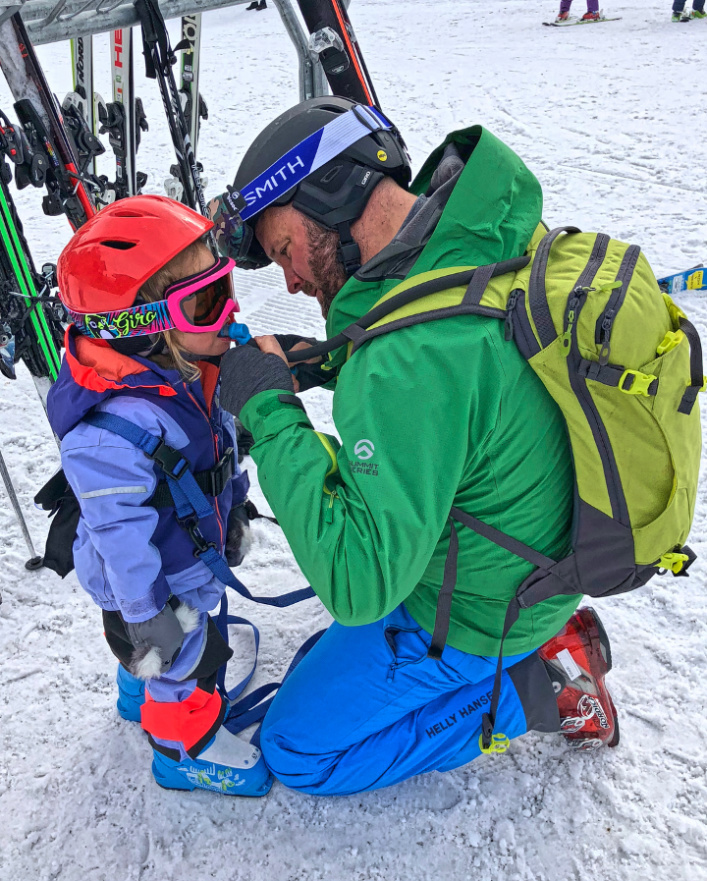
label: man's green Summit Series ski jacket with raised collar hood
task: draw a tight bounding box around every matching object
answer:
[240,126,580,657]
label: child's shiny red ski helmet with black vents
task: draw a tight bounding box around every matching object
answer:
[57,196,213,312]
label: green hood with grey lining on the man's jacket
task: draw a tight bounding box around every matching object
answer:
[327,126,543,342]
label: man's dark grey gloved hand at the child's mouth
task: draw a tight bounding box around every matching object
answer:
[221,337,295,416]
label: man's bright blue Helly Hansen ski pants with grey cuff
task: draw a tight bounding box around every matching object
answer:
[260,605,559,795]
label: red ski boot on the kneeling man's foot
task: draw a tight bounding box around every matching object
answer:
[538,608,619,750]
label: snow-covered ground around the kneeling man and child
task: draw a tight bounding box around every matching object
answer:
[0,0,707,881]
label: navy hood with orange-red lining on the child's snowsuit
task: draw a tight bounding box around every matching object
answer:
[47,325,181,440]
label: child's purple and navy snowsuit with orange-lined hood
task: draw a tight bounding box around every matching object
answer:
[47,329,248,701]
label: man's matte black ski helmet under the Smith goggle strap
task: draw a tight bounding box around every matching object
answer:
[233,96,412,275]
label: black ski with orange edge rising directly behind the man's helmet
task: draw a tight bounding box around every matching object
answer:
[297,0,380,110]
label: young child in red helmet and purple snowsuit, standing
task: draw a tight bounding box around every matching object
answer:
[48,196,271,796]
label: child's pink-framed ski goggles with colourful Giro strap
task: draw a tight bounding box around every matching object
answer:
[67,257,239,340]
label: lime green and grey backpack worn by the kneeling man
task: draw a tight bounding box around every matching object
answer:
[308,225,705,748]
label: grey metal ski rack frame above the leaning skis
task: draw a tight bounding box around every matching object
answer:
[0,0,328,101]
